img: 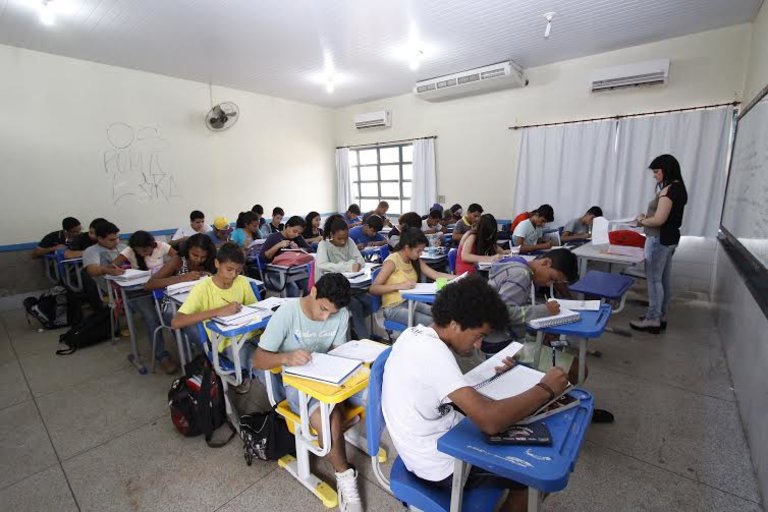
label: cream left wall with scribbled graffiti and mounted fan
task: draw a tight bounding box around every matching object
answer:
[0,46,335,245]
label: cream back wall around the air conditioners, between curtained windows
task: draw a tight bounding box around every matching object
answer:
[335,24,750,220]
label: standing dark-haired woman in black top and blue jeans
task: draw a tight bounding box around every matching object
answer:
[629,155,688,334]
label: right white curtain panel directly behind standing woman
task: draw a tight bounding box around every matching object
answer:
[613,107,733,237]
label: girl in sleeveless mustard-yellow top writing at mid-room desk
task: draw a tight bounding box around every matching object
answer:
[368,228,454,325]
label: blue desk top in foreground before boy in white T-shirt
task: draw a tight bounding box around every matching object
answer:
[437,389,594,492]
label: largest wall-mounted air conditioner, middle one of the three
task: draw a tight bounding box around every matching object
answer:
[413,60,528,101]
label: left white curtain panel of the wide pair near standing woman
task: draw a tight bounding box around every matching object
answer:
[514,120,616,226]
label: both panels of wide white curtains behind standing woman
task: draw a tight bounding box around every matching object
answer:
[514,107,733,236]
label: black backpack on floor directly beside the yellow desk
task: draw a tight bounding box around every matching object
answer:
[240,406,296,466]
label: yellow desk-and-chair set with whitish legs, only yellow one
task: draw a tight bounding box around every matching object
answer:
[264,368,387,508]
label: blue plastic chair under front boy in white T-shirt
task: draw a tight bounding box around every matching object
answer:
[365,348,504,512]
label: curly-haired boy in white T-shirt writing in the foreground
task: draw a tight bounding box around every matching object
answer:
[381,276,568,511]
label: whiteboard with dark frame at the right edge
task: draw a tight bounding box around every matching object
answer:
[720,88,768,268]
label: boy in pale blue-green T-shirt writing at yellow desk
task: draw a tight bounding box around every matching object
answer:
[253,274,363,511]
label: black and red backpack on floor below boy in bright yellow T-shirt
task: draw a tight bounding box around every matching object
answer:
[168,354,236,448]
